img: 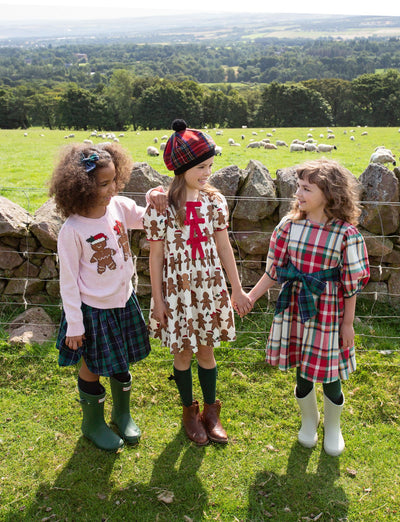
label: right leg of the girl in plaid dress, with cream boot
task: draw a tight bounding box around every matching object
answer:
[323,380,345,457]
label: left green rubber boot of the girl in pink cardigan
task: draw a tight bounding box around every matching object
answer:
[78,388,124,451]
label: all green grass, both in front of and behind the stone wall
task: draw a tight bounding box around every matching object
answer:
[0,128,400,522]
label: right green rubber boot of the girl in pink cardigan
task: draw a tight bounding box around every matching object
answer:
[110,377,141,444]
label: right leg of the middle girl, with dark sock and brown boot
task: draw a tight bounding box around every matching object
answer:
[196,346,228,444]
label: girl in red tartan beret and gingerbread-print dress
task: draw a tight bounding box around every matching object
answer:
[144,120,251,445]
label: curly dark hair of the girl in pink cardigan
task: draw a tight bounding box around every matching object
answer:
[49,142,133,218]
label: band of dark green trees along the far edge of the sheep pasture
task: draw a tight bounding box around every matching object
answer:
[0,70,400,130]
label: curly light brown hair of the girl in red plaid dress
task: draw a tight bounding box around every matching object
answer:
[288,158,361,225]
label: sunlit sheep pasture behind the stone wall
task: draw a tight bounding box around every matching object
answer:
[0,127,400,213]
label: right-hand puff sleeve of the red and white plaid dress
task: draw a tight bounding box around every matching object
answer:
[340,226,370,298]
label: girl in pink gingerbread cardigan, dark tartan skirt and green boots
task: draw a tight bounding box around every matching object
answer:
[50,143,166,450]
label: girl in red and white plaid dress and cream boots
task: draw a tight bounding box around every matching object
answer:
[249,158,369,456]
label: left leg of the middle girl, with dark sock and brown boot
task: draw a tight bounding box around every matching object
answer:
[174,350,208,446]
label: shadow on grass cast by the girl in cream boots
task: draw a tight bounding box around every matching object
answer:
[246,441,349,522]
